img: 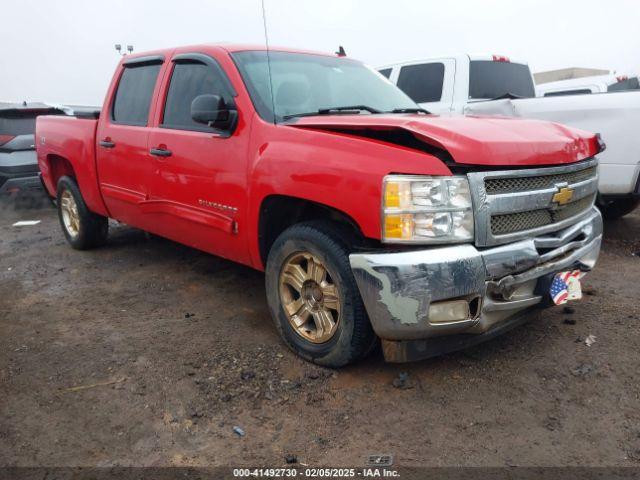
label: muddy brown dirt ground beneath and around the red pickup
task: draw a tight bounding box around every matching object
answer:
[0,200,640,467]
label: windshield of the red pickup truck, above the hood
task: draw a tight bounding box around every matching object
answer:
[232,51,420,121]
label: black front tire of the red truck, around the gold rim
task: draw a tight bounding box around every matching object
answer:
[265,221,377,368]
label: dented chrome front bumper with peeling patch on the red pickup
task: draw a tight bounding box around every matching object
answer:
[349,207,602,362]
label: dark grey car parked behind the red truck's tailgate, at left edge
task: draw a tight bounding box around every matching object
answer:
[0,103,64,199]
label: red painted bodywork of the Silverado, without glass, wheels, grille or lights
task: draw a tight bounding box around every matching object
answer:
[36,45,598,269]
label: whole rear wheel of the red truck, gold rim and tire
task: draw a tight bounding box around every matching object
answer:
[57,177,109,250]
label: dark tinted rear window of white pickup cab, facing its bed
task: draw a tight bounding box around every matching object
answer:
[469,60,536,100]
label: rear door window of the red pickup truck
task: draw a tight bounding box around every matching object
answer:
[111,63,161,126]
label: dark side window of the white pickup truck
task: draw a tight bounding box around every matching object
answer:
[398,62,444,103]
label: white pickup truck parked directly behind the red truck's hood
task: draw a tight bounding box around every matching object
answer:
[378,55,640,218]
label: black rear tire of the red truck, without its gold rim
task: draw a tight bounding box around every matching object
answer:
[56,177,109,250]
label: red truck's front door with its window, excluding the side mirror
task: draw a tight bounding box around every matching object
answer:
[147,53,249,259]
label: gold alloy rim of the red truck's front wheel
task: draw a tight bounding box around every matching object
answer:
[278,252,341,343]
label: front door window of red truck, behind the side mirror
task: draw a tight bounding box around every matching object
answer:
[162,61,233,131]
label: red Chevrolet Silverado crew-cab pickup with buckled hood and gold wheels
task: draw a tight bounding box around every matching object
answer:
[36,45,603,367]
